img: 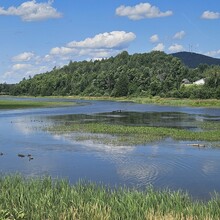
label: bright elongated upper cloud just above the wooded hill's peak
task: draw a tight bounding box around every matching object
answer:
[67,31,136,49]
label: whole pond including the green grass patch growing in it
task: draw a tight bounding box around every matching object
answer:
[0,97,220,200]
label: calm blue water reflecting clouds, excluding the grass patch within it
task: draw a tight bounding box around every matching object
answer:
[0,99,220,199]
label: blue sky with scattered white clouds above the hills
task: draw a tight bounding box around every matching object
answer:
[0,0,220,83]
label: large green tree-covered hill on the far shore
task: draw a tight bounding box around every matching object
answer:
[11,51,220,98]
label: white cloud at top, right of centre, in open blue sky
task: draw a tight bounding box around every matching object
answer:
[116,3,173,20]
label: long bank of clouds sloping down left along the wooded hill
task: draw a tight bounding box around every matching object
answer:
[0,31,136,83]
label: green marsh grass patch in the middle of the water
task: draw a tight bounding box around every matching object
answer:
[47,122,220,145]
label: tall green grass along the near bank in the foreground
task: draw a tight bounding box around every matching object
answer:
[0,176,220,220]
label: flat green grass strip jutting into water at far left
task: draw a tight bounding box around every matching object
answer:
[0,100,74,109]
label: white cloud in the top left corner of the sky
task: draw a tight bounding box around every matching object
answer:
[0,0,62,21]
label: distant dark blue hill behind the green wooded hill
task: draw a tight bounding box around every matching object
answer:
[172,52,220,68]
